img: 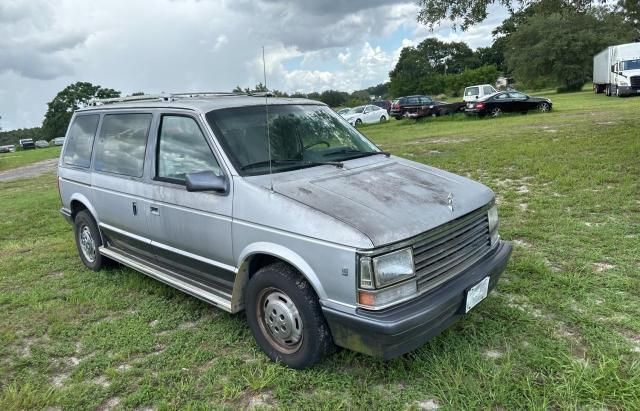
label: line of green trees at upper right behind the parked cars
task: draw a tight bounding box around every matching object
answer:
[400,0,640,95]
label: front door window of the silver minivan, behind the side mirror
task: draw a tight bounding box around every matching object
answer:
[156,115,222,184]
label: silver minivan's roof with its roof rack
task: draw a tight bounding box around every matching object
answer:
[77,94,326,113]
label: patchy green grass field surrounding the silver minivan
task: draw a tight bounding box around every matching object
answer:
[0,92,640,410]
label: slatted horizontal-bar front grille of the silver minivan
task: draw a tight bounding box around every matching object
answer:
[413,207,491,292]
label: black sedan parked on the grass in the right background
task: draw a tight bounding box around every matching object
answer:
[464,91,553,117]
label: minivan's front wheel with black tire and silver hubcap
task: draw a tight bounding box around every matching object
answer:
[244,262,334,369]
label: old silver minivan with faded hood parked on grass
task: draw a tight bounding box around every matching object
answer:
[58,93,511,368]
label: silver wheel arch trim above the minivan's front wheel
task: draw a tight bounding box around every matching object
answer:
[231,242,326,313]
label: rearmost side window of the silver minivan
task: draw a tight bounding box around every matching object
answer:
[64,114,100,168]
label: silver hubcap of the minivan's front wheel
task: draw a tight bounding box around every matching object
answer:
[261,290,302,352]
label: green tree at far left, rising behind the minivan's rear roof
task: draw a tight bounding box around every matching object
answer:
[42,81,120,138]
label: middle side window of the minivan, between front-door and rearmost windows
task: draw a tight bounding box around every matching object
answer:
[94,114,152,177]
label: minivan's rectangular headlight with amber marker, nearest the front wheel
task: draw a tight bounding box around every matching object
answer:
[358,248,417,309]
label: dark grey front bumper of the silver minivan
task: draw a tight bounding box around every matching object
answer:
[322,241,512,359]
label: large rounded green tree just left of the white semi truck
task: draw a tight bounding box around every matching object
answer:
[505,13,630,91]
